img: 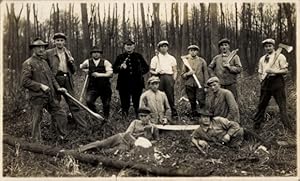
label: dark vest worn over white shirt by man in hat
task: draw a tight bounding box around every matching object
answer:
[88,58,110,89]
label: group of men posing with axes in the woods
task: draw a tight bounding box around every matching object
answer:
[22,33,292,150]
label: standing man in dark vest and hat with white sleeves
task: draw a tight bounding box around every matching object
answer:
[80,46,113,120]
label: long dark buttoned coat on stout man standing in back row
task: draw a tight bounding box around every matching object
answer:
[113,52,149,91]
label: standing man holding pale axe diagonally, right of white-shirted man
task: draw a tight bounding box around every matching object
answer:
[181,45,208,116]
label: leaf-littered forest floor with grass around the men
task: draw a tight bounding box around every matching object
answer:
[3,72,297,177]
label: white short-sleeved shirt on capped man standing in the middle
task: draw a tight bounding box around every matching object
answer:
[150,53,177,74]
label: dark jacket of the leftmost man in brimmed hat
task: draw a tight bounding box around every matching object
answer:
[22,55,59,97]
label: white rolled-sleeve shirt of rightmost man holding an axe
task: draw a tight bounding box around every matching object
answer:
[258,51,289,77]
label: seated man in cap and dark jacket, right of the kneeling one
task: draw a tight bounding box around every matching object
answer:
[207,77,240,123]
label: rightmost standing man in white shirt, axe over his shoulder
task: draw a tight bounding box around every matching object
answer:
[253,38,294,133]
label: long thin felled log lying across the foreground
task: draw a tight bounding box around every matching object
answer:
[3,135,213,177]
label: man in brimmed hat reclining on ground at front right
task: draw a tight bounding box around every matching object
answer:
[192,111,244,153]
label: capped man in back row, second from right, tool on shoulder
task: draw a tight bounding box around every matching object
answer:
[208,38,242,100]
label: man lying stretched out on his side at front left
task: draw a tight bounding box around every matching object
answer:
[78,108,158,152]
